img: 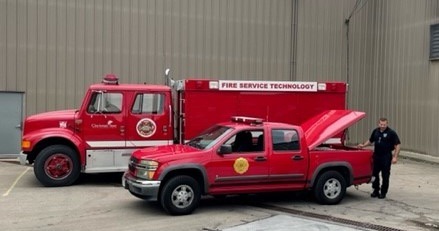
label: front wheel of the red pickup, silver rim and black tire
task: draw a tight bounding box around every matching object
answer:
[160,176,201,215]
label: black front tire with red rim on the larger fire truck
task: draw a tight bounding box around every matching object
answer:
[34,145,80,187]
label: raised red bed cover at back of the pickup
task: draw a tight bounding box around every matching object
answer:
[301,110,366,150]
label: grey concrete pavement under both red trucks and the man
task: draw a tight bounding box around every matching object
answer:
[0,153,439,231]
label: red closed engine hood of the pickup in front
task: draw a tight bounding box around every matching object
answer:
[133,144,200,161]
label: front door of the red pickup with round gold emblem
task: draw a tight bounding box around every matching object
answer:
[208,130,269,193]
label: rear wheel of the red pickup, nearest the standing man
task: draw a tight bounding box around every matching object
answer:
[314,171,346,205]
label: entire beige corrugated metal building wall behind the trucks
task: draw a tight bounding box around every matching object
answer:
[0,0,439,156]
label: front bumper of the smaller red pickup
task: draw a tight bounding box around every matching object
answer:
[122,172,161,201]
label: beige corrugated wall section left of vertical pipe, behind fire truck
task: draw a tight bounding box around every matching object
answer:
[0,0,293,115]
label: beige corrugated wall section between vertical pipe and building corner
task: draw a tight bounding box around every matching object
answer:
[296,0,346,81]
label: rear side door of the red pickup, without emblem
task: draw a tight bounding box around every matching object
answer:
[270,129,309,189]
